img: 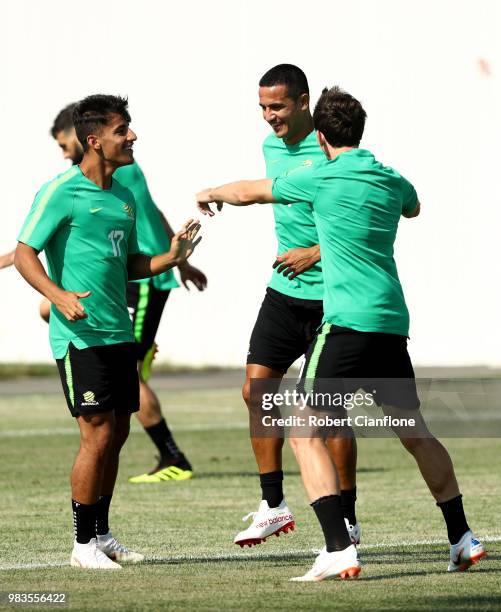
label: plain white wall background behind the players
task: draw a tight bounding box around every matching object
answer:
[0,0,501,365]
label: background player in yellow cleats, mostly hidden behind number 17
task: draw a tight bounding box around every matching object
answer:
[48,104,207,483]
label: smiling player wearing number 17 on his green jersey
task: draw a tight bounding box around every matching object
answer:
[15,95,200,569]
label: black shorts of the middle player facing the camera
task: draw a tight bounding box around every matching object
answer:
[247,287,324,373]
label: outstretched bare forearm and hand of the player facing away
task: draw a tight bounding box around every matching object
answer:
[196,179,275,216]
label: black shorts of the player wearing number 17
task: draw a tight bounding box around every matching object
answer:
[56,342,139,417]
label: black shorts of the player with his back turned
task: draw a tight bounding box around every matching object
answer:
[299,323,420,409]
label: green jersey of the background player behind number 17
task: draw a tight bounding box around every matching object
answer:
[113,162,179,291]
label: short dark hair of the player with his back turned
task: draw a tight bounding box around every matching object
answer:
[313,87,367,147]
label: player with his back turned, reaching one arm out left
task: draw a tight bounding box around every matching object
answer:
[197,87,485,581]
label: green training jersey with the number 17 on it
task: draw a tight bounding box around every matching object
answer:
[18,166,139,359]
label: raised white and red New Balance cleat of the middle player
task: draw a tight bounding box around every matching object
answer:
[233,499,296,548]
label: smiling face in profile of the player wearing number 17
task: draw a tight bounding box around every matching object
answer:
[87,113,137,168]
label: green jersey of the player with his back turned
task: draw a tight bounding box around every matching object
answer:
[273,149,417,336]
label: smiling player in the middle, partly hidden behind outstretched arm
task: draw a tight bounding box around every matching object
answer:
[228,64,360,546]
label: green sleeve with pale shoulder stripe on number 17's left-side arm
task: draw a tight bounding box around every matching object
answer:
[17,181,73,251]
